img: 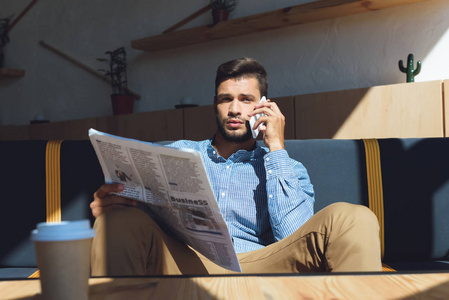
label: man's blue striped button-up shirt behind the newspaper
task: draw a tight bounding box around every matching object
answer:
[168,139,314,253]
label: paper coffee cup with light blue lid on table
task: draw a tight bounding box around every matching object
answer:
[31,220,95,300]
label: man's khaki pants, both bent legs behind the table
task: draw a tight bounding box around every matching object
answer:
[92,203,382,276]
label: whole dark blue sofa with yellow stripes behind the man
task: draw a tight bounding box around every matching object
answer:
[0,138,449,278]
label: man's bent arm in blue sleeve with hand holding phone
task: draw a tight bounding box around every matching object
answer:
[249,100,315,241]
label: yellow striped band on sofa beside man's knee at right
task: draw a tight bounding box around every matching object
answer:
[363,139,385,259]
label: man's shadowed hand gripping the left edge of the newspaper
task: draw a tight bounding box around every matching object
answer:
[90,183,137,218]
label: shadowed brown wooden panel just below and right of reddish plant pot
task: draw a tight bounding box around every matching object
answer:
[118,110,183,141]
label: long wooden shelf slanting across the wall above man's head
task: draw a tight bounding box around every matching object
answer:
[131,0,430,51]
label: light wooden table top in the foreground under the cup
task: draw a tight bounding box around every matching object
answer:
[0,272,449,300]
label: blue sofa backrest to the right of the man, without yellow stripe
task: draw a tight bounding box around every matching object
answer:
[286,138,449,262]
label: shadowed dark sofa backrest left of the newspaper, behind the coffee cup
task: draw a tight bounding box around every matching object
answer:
[0,140,104,267]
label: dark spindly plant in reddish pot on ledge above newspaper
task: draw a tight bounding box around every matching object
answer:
[97,47,134,115]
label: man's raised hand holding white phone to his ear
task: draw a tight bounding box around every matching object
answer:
[248,100,285,151]
